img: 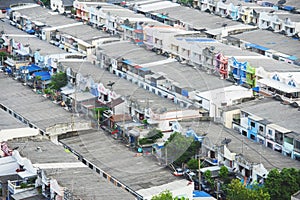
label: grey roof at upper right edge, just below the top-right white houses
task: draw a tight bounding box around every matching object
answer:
[231,30,300,59]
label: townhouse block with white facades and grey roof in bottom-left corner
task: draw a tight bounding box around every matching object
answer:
[0,138,134,199]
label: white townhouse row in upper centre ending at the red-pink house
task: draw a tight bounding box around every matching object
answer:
[144,27,228,79]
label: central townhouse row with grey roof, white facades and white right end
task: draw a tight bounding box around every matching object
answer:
[59,57,201,131]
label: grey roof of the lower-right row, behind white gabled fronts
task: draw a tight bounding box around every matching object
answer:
[180,120,300,170]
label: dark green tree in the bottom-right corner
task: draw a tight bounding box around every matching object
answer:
[264,168,300,200]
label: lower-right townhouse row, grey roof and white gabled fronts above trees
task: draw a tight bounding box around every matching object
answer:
[179,121,299,186]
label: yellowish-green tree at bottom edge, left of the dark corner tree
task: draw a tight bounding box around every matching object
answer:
[226,179,270,200]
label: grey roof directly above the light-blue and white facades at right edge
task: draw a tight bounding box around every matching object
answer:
[241,98,300,134]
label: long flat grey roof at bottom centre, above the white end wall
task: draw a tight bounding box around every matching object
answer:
[61,131,178,191]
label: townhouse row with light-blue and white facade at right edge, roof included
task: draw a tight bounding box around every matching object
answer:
[225,99,300,160]
